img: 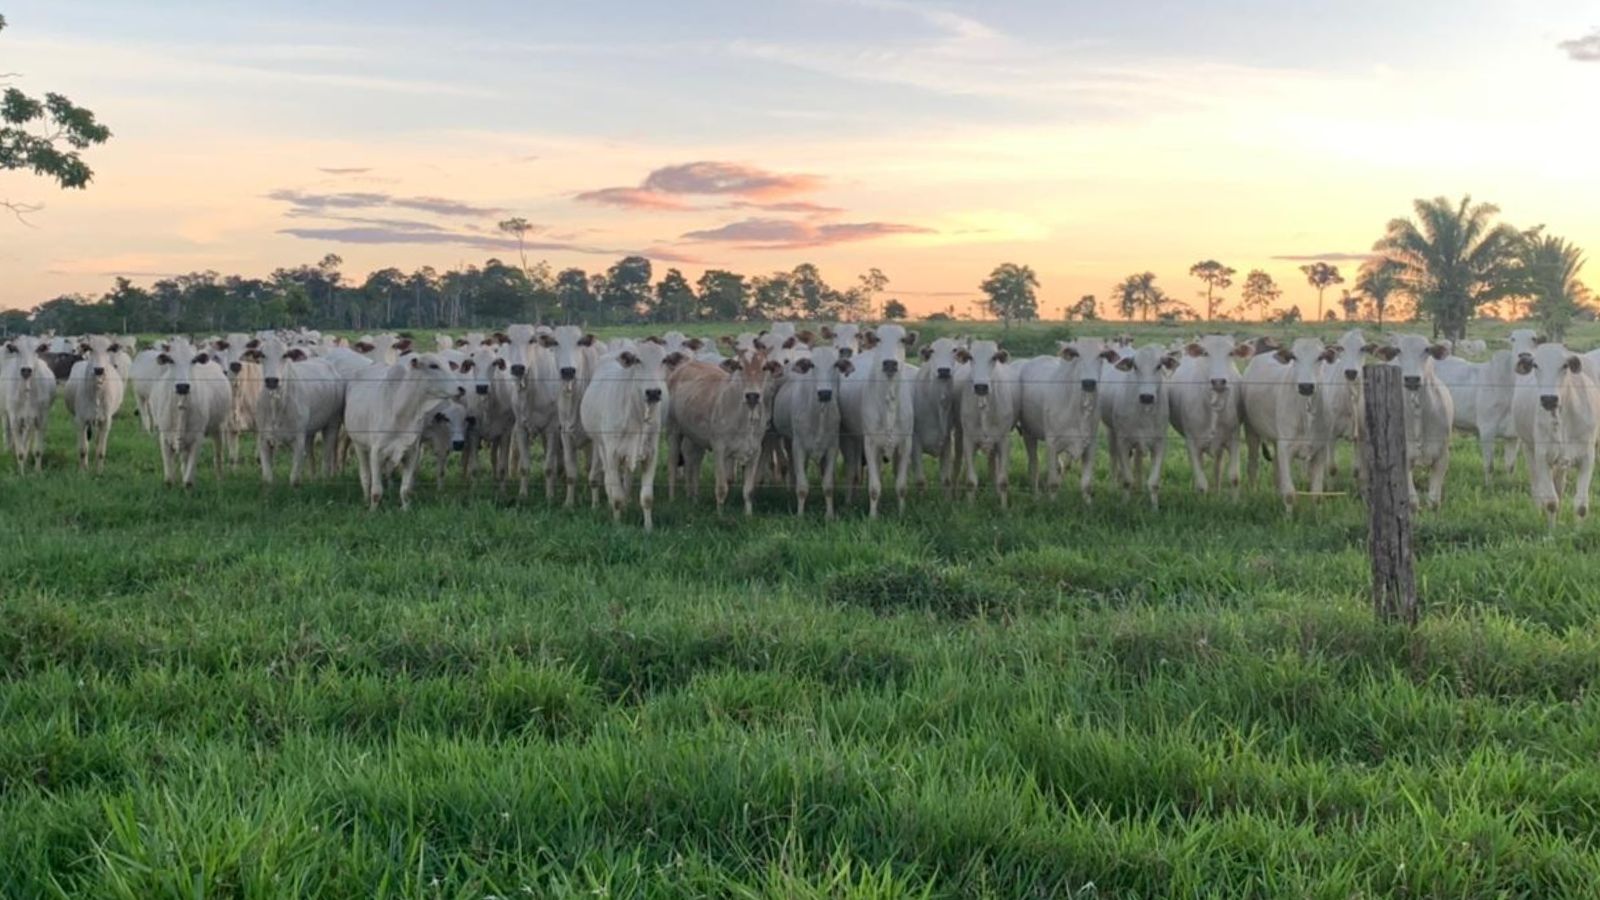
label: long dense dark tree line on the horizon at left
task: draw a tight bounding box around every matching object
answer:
[0,255,906,335]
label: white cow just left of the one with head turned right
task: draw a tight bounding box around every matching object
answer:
[245,338,344,485]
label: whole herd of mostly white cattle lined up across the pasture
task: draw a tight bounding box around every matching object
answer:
[0,323,1600,528]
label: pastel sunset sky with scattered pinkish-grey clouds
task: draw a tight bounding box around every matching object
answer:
[0,0,1600,317]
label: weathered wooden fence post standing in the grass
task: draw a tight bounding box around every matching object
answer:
[1362,365,1418,626]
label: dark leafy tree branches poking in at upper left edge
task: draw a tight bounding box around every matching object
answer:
[0,16,110,216]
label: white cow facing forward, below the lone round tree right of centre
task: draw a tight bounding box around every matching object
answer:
[955,341,1022,509]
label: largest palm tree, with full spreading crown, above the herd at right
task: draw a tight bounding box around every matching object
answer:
[1373,197,1523,341]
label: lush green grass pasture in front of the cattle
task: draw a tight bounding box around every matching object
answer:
[0,323,1600,898]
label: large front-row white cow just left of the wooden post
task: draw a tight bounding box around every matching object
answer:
[1242,338,1338,512]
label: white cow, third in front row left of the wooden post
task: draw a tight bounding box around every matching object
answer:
[1099,344,1178,509]
